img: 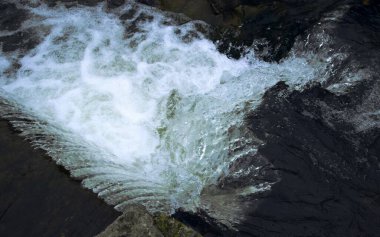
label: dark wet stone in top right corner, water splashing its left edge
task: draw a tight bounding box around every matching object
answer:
[293,2,380,87]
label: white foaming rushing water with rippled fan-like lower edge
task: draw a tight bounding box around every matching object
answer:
[0,1,315,212]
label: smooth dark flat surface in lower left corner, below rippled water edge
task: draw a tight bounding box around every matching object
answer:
[0,121,120,237]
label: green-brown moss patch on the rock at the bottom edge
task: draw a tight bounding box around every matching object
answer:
[153,214,202,237]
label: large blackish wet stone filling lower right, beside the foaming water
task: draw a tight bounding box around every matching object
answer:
[238,80,380,236]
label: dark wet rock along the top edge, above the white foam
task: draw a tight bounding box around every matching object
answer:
[140,0,356,61]
